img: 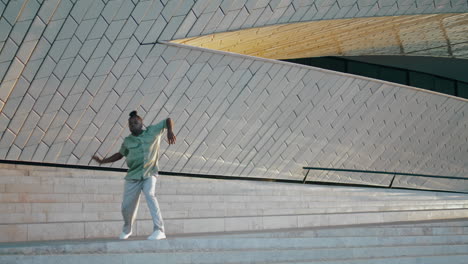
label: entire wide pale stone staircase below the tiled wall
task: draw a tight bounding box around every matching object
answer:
[0,164,468,264]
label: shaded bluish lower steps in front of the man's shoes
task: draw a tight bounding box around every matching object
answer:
[0,237,468,264]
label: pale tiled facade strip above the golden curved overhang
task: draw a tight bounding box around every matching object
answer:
[175,0,468,40]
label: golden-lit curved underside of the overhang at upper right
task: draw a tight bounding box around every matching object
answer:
[173,13,468,59]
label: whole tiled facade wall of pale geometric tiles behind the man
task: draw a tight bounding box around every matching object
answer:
[0,0,468,192]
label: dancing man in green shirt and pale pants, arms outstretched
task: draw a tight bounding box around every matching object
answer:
[93,111,176,240]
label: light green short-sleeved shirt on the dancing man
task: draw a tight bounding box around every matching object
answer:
[119,120,166,180]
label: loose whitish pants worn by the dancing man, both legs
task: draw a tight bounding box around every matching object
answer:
[122,176,164,234]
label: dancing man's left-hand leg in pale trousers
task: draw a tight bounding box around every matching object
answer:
[122,180,143,234]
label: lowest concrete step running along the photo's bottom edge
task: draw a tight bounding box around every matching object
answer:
[0,252,468,264]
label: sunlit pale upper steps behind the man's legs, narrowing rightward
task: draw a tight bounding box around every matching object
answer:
[0,166,468,242]
